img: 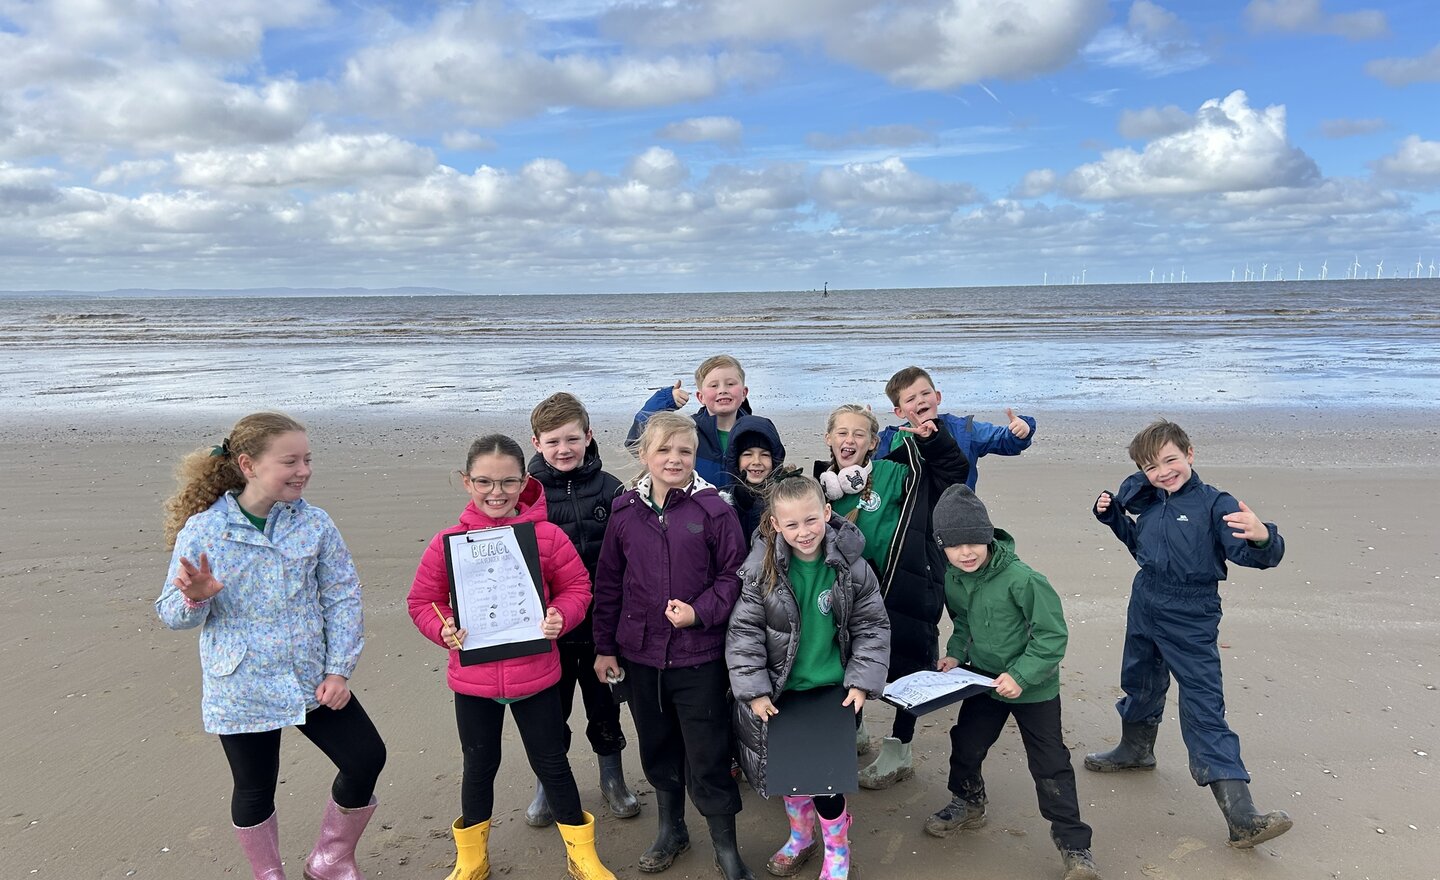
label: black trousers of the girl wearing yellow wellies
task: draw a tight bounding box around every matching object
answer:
[455,686,585,828]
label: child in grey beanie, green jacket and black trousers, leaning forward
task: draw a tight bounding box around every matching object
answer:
[924,485,1100,880]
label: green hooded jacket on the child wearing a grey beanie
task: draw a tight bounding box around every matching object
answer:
[945,529,1070,703]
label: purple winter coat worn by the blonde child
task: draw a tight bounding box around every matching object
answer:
[590,475,746,668]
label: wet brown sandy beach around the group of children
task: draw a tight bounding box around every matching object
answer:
[0,409,1440,880]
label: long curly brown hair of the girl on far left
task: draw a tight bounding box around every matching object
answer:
[164,412,305,547]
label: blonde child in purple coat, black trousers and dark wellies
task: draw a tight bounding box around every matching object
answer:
[593,412,753,880]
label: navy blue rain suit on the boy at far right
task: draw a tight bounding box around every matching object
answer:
[1094,472,1284,785]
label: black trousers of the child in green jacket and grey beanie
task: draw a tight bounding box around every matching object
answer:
[949,694,1090,850]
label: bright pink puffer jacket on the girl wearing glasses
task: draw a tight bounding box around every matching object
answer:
[408,478,590,700]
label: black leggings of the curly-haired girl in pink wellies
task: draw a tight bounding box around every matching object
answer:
[220,696,384,828]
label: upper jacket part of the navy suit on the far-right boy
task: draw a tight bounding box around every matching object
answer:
[1092,471,1284,589]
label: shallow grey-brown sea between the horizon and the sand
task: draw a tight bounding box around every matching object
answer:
[0,279,1440,421]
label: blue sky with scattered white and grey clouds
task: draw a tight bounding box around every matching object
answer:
[0,0,1440,292]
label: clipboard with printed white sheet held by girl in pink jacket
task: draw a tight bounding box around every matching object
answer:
[445,523,553,665]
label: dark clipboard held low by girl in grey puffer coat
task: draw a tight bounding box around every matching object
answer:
[763,684,860,796]
